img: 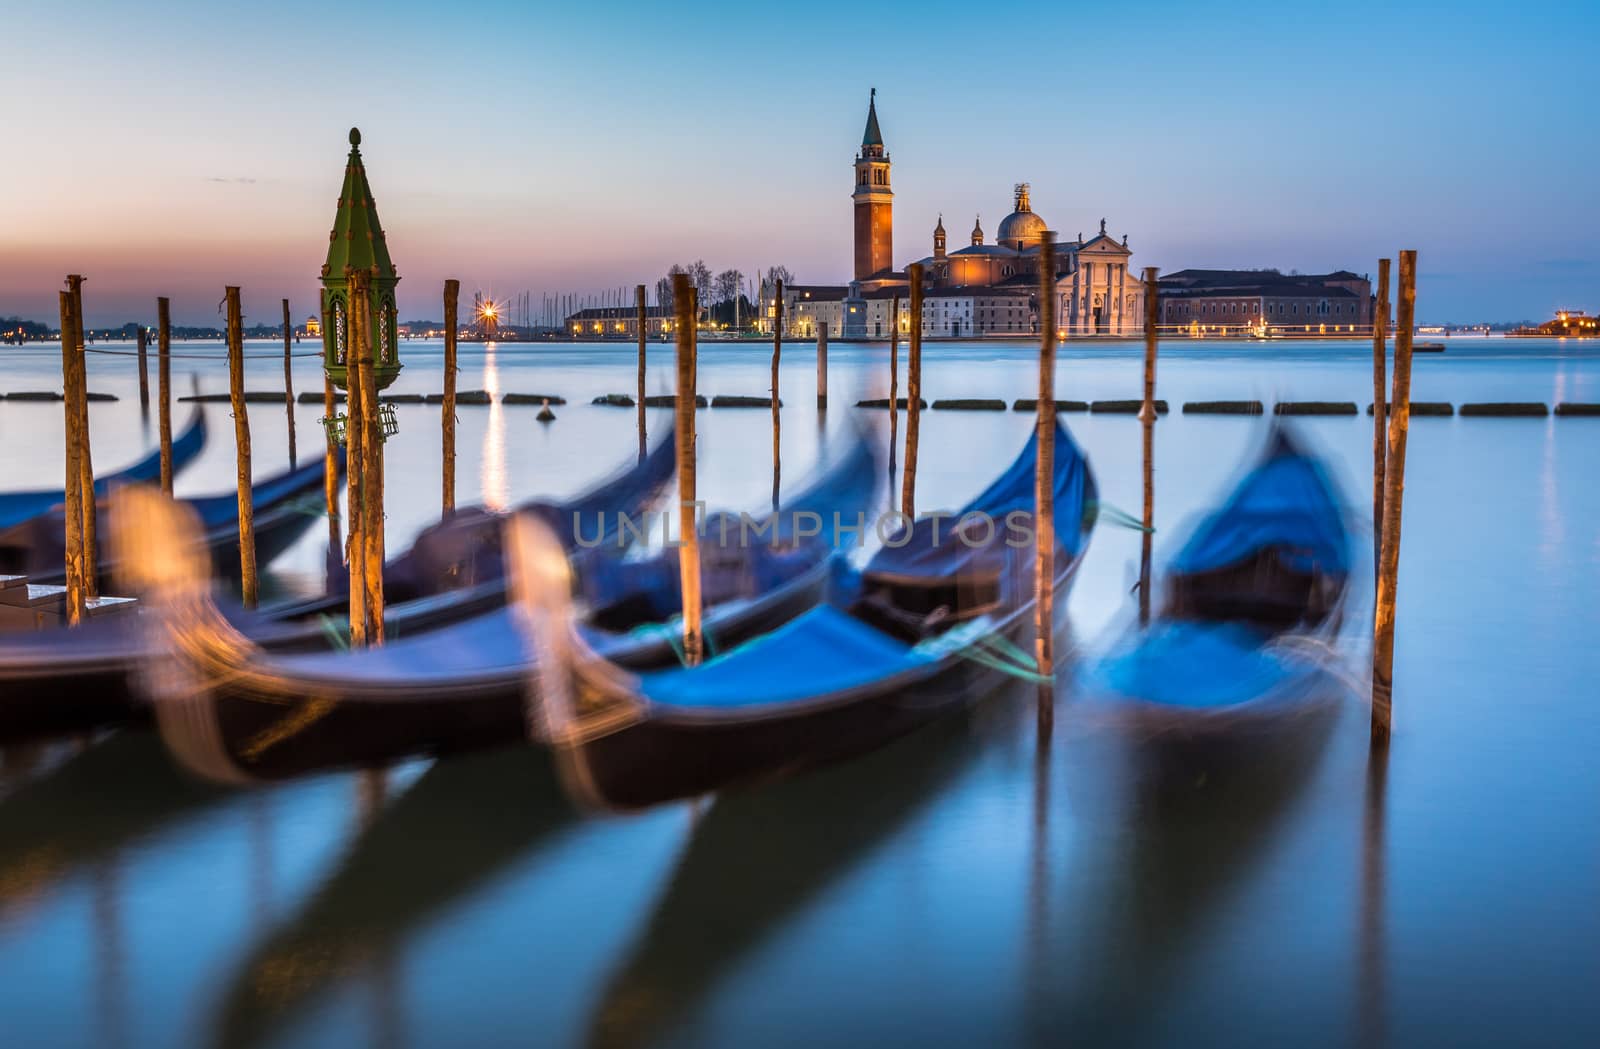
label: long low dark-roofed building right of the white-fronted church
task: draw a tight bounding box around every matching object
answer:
[1158,270,1373,334]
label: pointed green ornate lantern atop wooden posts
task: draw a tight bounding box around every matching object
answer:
[322,128,400,390]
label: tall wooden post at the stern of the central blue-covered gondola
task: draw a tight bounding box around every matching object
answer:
[1030,238,1056,740]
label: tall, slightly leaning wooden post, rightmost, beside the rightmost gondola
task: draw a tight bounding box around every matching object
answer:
[1373,251,1416,747]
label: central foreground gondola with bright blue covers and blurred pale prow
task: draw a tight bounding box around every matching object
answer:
[528,425,1098,808]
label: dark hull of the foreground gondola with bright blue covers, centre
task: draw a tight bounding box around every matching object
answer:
[562,558,1082,809]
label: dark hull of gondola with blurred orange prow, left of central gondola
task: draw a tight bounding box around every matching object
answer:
[157,563,827,780]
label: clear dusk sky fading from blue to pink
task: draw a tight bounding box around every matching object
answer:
[0,0,1600,325]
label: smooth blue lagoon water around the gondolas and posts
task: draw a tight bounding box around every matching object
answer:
[0,339,1600,1047]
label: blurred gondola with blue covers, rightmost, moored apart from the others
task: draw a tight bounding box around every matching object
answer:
[1077,425,1352,788]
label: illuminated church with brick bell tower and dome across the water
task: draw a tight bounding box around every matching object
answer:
[784,91,1144,339]
